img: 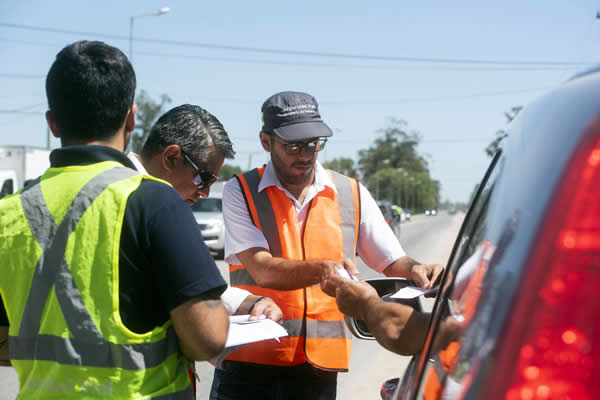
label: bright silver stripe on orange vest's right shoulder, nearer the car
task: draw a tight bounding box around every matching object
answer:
[330,171,358,261]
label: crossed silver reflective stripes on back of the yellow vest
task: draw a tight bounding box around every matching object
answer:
[9,167,178,369]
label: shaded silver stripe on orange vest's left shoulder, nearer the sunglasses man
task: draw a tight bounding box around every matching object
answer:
[242,169,282,257]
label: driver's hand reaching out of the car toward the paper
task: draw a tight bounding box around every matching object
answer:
[335,277,380,319]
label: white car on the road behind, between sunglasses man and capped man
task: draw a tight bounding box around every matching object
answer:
[192,192,225,258]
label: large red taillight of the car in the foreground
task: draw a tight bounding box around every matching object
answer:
[483,119,600,400]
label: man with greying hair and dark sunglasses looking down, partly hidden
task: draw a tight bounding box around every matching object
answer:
[127,104,282,322]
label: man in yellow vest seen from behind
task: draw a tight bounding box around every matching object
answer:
[0,41,229,399]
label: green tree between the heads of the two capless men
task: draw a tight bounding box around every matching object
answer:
[129,90,171,153]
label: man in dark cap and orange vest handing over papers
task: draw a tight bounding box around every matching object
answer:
[211,92,443,400]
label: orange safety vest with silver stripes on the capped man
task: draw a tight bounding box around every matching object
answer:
[227,166,360,371]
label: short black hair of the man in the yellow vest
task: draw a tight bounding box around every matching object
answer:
[46,40,136,140]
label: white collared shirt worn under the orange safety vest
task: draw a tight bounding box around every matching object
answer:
[223,161,406,272]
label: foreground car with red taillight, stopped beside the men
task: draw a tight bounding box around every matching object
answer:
[344,67,600,400]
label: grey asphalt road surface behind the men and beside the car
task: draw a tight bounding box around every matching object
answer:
[0,213,464,400]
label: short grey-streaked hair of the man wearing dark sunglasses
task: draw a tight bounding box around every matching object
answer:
[141,104,235,161]
